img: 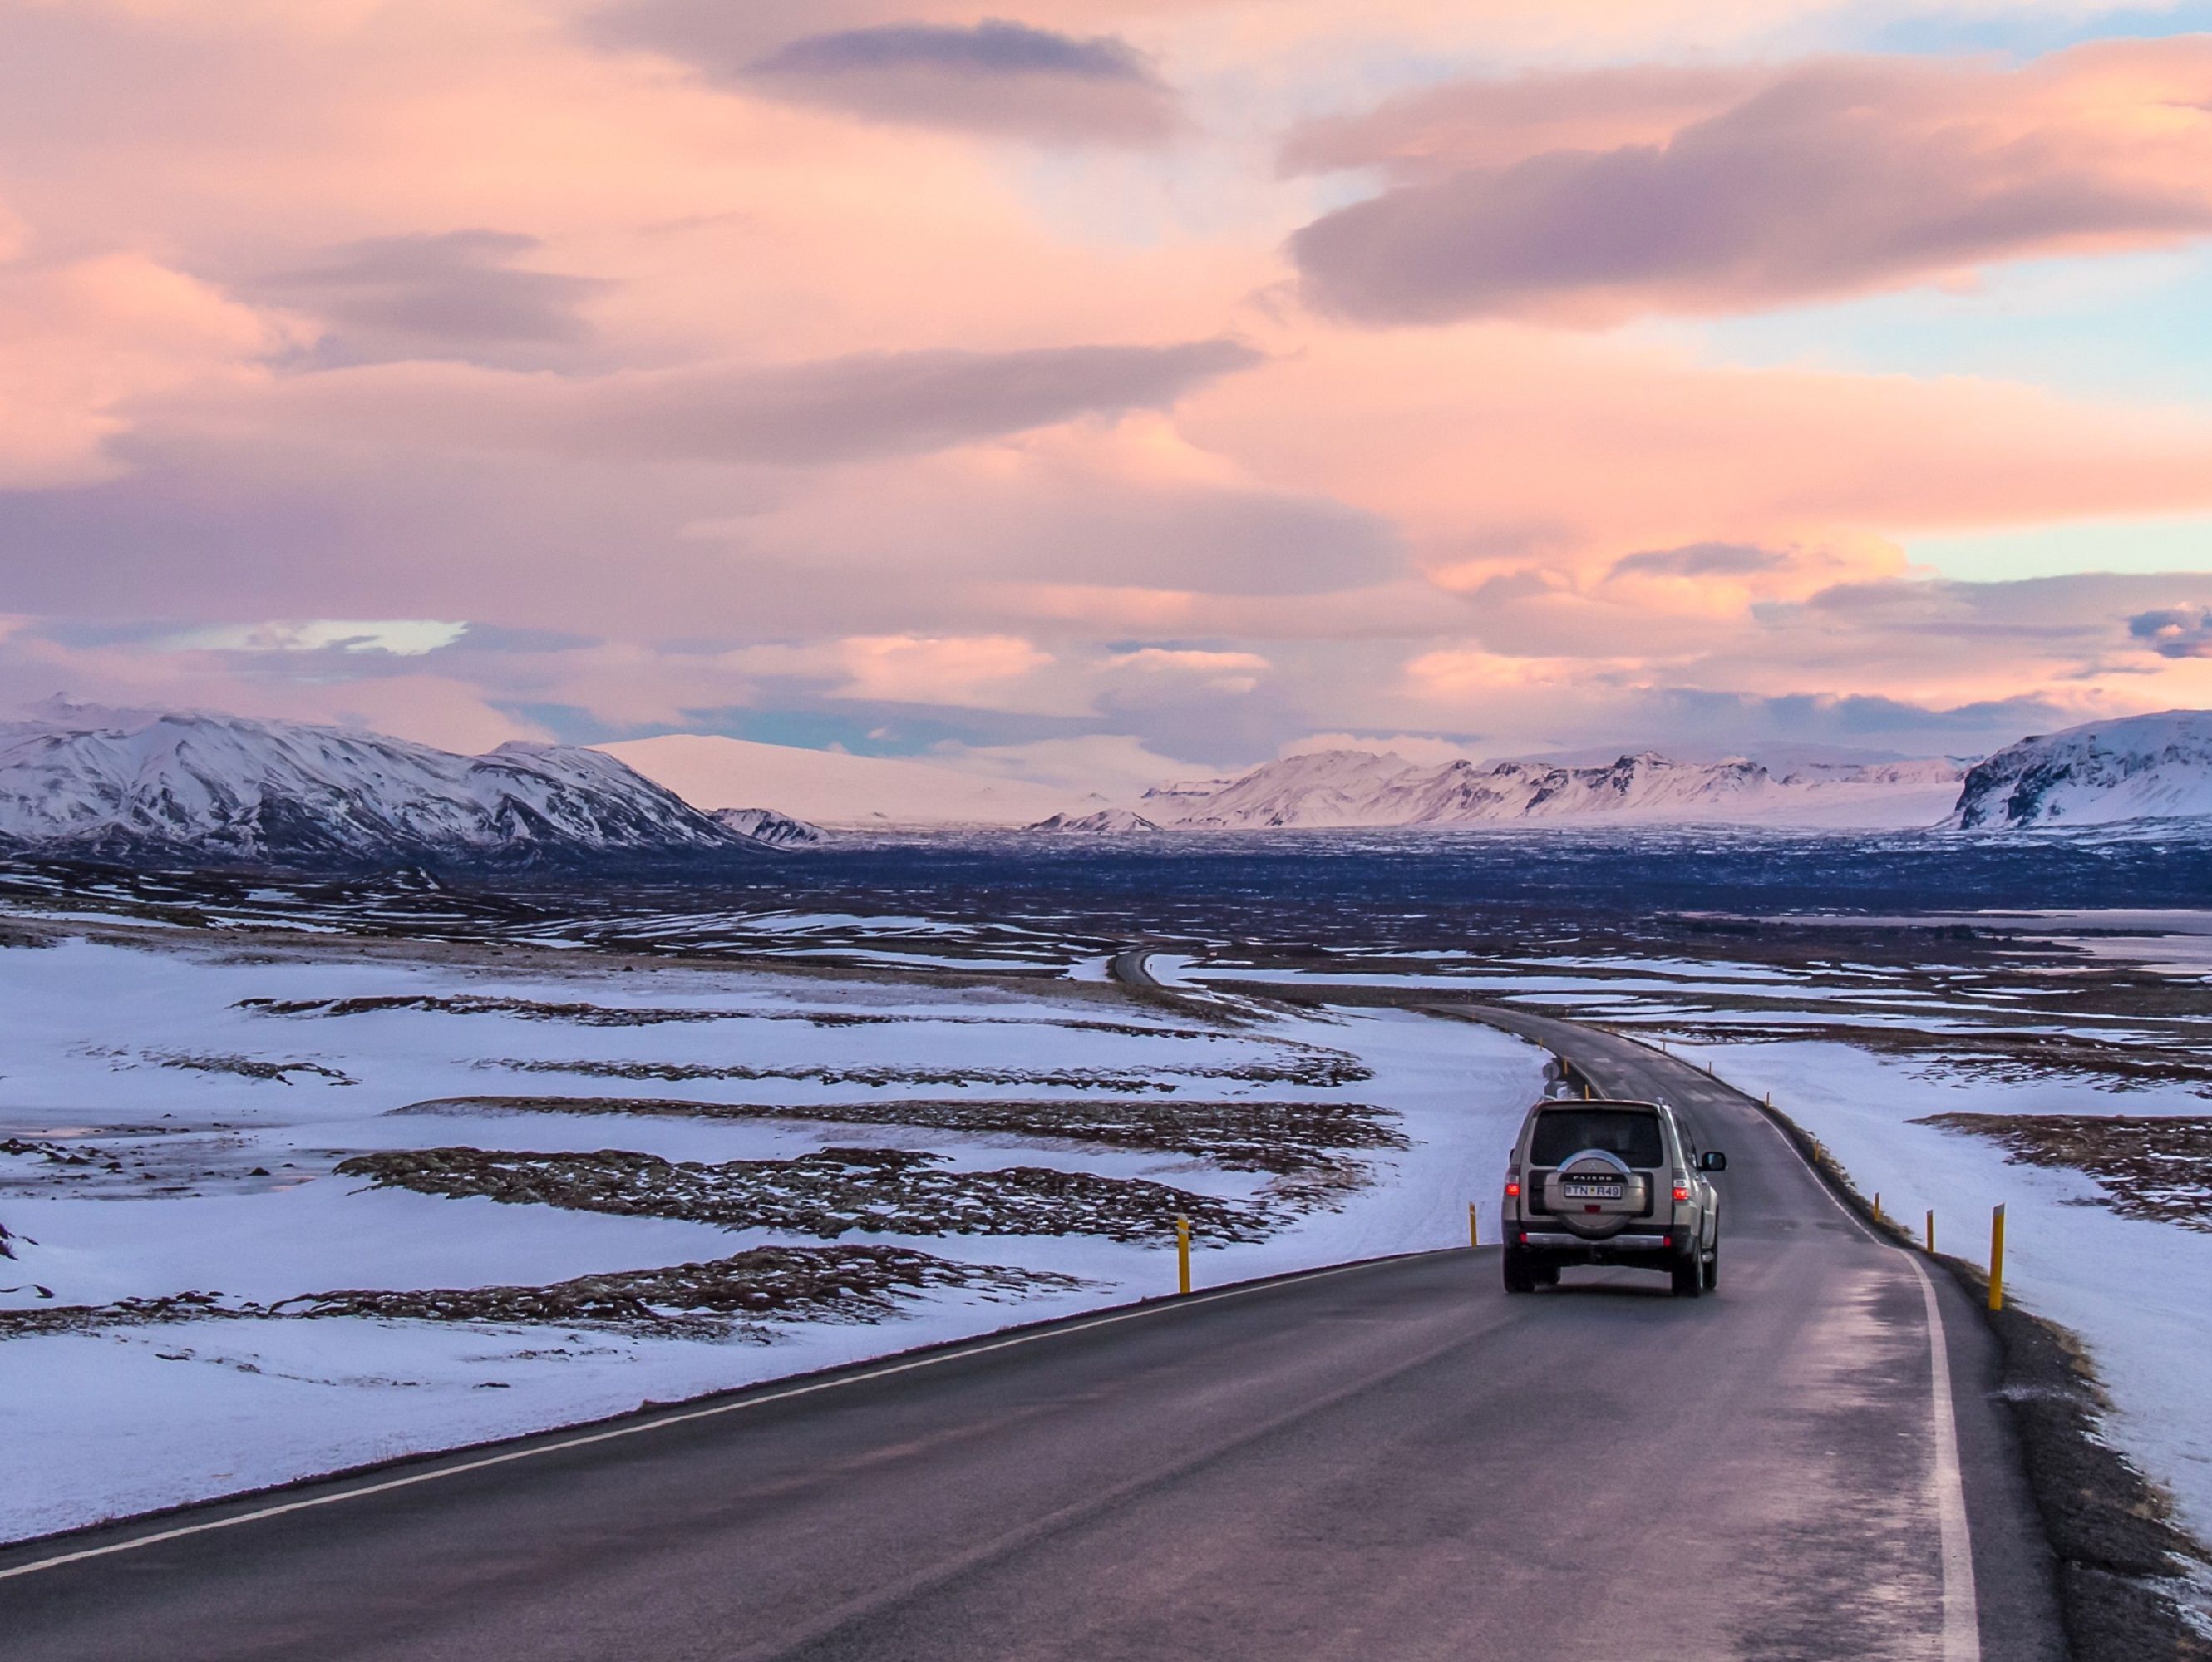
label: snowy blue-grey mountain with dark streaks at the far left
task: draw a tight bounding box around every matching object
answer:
[0,703,763,870]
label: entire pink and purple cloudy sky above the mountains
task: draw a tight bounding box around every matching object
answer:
[0,0,2212,783]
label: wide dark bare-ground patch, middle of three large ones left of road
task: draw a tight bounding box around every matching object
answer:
[336,1148,1269,1241]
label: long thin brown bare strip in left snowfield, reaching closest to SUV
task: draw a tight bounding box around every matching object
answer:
[401,1096,1409,1177]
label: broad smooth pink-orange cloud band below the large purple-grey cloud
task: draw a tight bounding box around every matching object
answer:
[1177,323,2212,586]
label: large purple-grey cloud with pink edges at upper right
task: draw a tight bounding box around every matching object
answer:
[1289,36,2212,323]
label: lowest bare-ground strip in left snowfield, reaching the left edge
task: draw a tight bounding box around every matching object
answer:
[0,1246,1084,1339]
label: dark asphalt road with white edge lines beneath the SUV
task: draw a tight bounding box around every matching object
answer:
[0,982,2062,1662]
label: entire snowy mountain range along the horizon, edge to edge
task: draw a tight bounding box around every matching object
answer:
[0,702,2212,874]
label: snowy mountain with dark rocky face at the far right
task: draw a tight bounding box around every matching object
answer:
[1953,710,2212,830]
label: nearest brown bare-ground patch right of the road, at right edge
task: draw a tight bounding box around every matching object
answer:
[1914,1113,2212,1233]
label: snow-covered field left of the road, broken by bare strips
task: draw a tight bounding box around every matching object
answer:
[0,932,1544,1538]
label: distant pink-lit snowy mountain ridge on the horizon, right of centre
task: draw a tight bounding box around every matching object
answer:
[1139,750,1960,830]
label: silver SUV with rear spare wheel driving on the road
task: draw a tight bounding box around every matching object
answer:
[1500,1100,1727,1299]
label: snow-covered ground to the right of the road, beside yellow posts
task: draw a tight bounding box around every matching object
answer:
[1673,1040,2212,1538]
